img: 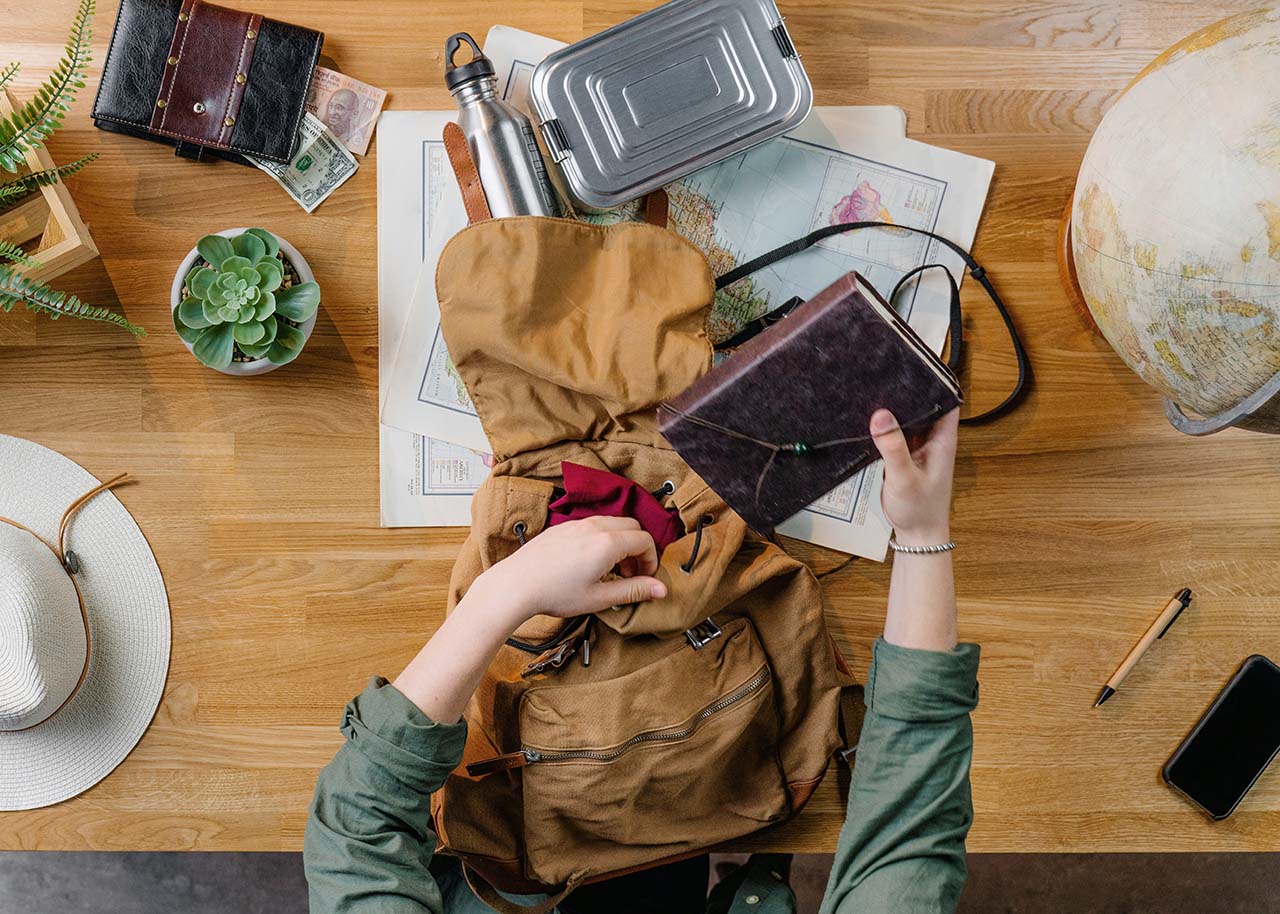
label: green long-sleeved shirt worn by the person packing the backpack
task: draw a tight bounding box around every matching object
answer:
[303,639,978,914]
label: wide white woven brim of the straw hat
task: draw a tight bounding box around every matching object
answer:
[0,435,170,810]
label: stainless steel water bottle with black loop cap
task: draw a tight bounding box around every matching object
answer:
[444,32,561,218]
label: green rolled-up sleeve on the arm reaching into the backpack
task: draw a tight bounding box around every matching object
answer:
[303,678,466,914]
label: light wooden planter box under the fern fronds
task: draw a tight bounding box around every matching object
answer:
[0,88,97,279]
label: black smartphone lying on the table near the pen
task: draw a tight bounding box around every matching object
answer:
[1164,654,1280,819]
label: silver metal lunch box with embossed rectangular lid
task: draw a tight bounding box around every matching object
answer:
[530,0,813,210]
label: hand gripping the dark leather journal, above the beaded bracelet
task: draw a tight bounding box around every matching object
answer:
[870,408,960,545]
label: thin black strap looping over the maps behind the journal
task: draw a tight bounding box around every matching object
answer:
[716,221,1032,425]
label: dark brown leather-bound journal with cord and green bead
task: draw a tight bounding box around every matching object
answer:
[658,273,963,530]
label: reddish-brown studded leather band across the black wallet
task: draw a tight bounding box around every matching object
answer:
[151,0,262,152]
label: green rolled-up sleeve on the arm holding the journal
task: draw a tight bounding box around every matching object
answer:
[819,639,978,914]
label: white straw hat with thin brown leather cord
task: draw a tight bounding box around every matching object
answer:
[0,435,170,809]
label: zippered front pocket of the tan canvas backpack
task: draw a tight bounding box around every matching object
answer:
[520,618,788,883]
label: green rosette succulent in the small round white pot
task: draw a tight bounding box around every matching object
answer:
[173,228,320,369]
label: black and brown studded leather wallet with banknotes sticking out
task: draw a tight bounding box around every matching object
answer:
[93,0,324,165]
